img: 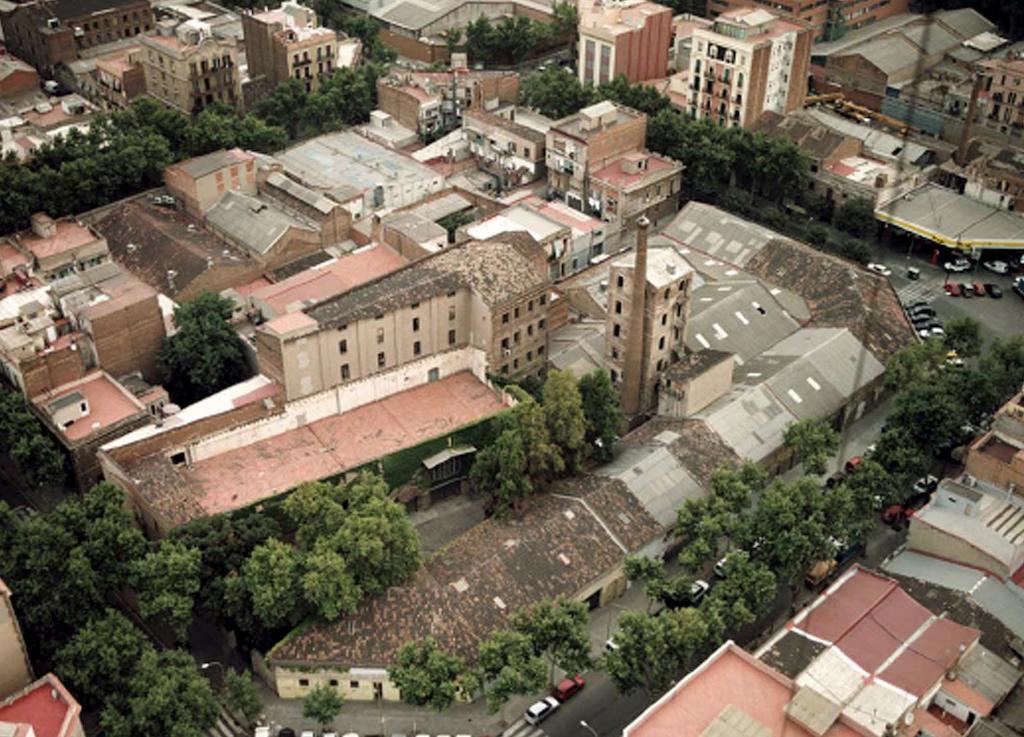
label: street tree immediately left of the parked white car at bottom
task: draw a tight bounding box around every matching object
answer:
[477,630,548,713]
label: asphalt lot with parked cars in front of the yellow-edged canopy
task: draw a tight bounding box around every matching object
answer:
[874,245,1024,343]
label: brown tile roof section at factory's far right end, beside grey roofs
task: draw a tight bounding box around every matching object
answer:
[743,239,913,363]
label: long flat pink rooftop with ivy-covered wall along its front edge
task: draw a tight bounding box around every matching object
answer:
[187,370,505,514]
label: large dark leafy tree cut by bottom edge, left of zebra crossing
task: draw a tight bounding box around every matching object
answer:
[99,650,218,737]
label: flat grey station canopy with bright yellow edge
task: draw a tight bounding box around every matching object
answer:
[874,183,1024,250]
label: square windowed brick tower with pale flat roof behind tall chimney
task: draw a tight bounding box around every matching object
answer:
[604,244,693,411]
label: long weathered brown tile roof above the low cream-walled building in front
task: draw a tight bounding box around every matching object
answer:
[269,481,657,666]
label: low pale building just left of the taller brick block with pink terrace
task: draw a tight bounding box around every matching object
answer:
[462,105,551,191]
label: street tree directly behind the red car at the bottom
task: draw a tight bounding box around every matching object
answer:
[512,599,590,684]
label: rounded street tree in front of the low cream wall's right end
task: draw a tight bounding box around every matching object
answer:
[388,637,466,712]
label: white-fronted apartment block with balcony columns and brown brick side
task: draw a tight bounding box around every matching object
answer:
[689,8,812,128]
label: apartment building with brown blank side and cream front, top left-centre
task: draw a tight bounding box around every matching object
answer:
[242,0,338,95]
